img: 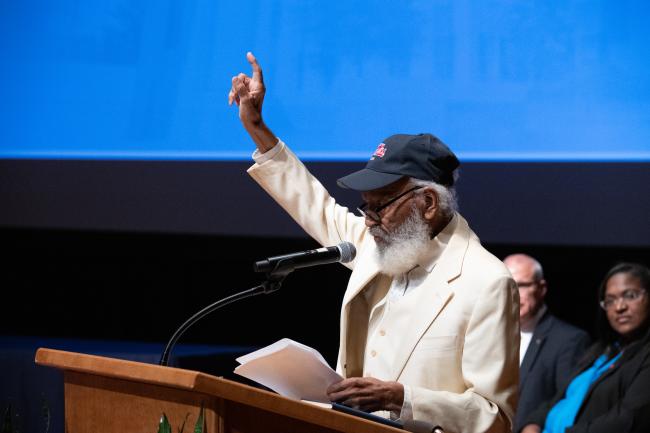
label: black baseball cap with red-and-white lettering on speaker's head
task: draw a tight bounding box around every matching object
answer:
[336,134,460,191]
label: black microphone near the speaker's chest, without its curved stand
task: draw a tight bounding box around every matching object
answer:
[253,242,357,274]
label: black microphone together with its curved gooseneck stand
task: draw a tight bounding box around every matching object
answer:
[158,242,356,365]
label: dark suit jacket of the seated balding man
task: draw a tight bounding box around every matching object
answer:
[514,312,590,432]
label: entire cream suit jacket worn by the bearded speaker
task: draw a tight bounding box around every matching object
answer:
[248,142,519,433]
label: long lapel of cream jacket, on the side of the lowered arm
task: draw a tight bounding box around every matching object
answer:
[392,215,470,380]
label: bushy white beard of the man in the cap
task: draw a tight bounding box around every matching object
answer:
[369,206,431,277]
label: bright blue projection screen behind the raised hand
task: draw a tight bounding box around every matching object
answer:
[0,0,650,161]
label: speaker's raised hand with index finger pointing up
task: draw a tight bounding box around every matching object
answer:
[228,52,266,126]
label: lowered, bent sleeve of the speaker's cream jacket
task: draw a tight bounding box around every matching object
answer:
[412,276,519,433]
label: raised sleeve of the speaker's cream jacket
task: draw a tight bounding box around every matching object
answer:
[248,141,366,268]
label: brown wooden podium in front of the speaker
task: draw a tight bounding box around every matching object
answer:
[36,348,403,433]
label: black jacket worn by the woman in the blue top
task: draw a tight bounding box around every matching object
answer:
[525,333,650,433]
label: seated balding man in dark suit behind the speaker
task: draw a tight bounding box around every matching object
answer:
[504,254,589,432]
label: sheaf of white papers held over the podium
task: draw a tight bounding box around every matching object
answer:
[235,338,343,403]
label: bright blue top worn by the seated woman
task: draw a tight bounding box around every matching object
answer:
[543,352,623,433]
